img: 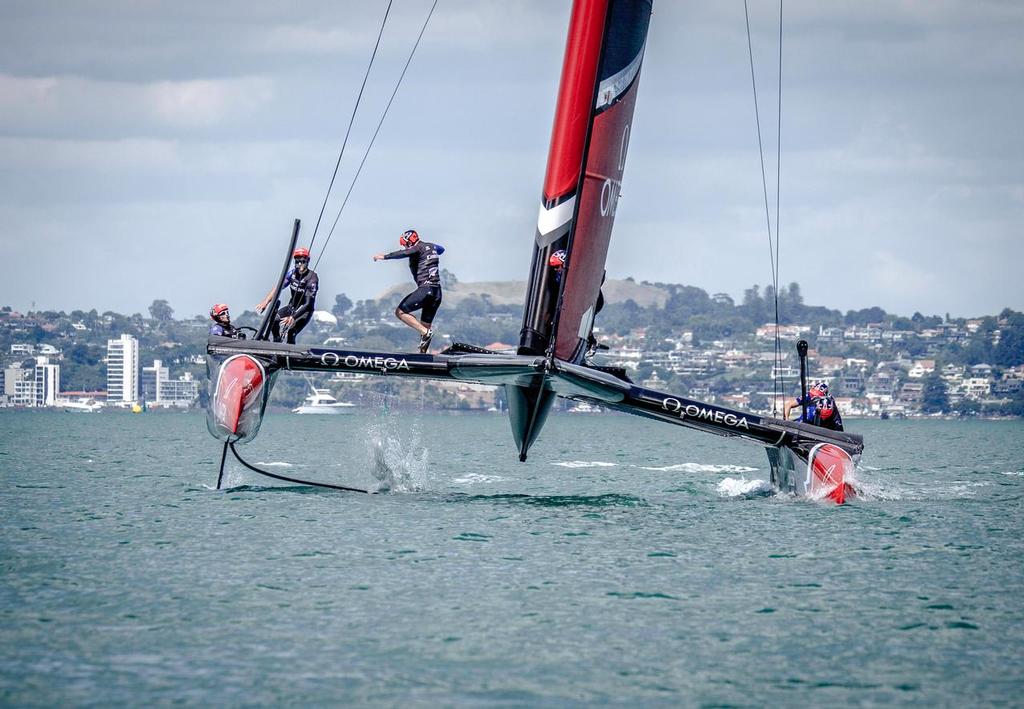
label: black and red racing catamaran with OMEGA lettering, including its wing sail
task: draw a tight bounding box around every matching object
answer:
[207,0,863,503]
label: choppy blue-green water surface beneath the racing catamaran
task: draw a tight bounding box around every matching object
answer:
[0,412,1024,706]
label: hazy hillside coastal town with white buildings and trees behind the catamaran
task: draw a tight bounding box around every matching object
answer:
[0,274,1024,418]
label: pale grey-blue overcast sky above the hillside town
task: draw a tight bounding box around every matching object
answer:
[0,0,1024,317]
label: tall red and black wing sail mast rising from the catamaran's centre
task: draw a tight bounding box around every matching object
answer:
[519,0,651,362]
